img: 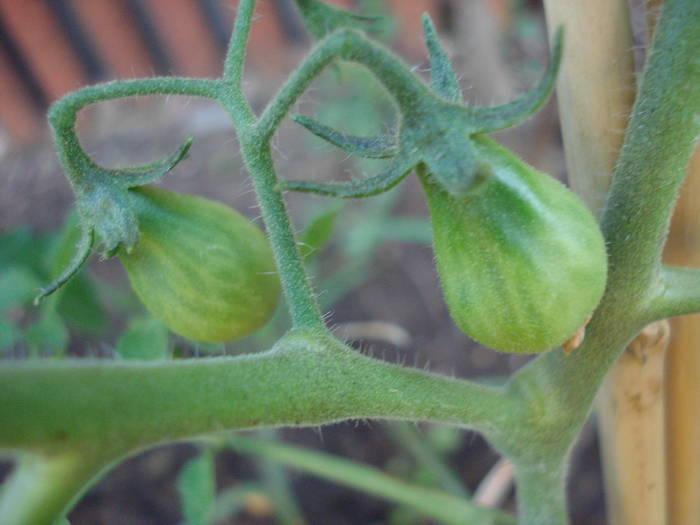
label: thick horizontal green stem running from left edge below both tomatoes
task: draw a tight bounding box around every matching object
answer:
[0,333,517,457]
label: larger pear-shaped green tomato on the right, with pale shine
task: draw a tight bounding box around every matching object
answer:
[422,136,607,353]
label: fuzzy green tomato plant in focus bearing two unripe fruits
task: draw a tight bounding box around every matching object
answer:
[0,0,700,525]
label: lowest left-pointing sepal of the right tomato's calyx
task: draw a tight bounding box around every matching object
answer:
[277,156,415,199]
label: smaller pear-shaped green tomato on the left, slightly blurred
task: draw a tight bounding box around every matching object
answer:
[119,186,280,342]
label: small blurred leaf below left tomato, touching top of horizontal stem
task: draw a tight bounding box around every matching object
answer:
[115,317,170,360]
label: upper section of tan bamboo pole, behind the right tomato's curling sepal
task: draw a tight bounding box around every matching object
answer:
[544,0,635,216]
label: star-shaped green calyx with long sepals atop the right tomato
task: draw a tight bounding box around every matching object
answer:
[278,15,563,198]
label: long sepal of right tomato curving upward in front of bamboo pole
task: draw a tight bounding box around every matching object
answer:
[469,27,564,133]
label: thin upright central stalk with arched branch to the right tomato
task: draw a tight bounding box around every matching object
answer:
[227,26,427,329]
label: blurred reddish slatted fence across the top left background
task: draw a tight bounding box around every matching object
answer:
[0,0,447,143]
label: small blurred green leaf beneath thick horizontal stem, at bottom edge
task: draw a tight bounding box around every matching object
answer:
[177,450,216,525]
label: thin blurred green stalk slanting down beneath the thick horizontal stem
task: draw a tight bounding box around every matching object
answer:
[231,436,514,525]
